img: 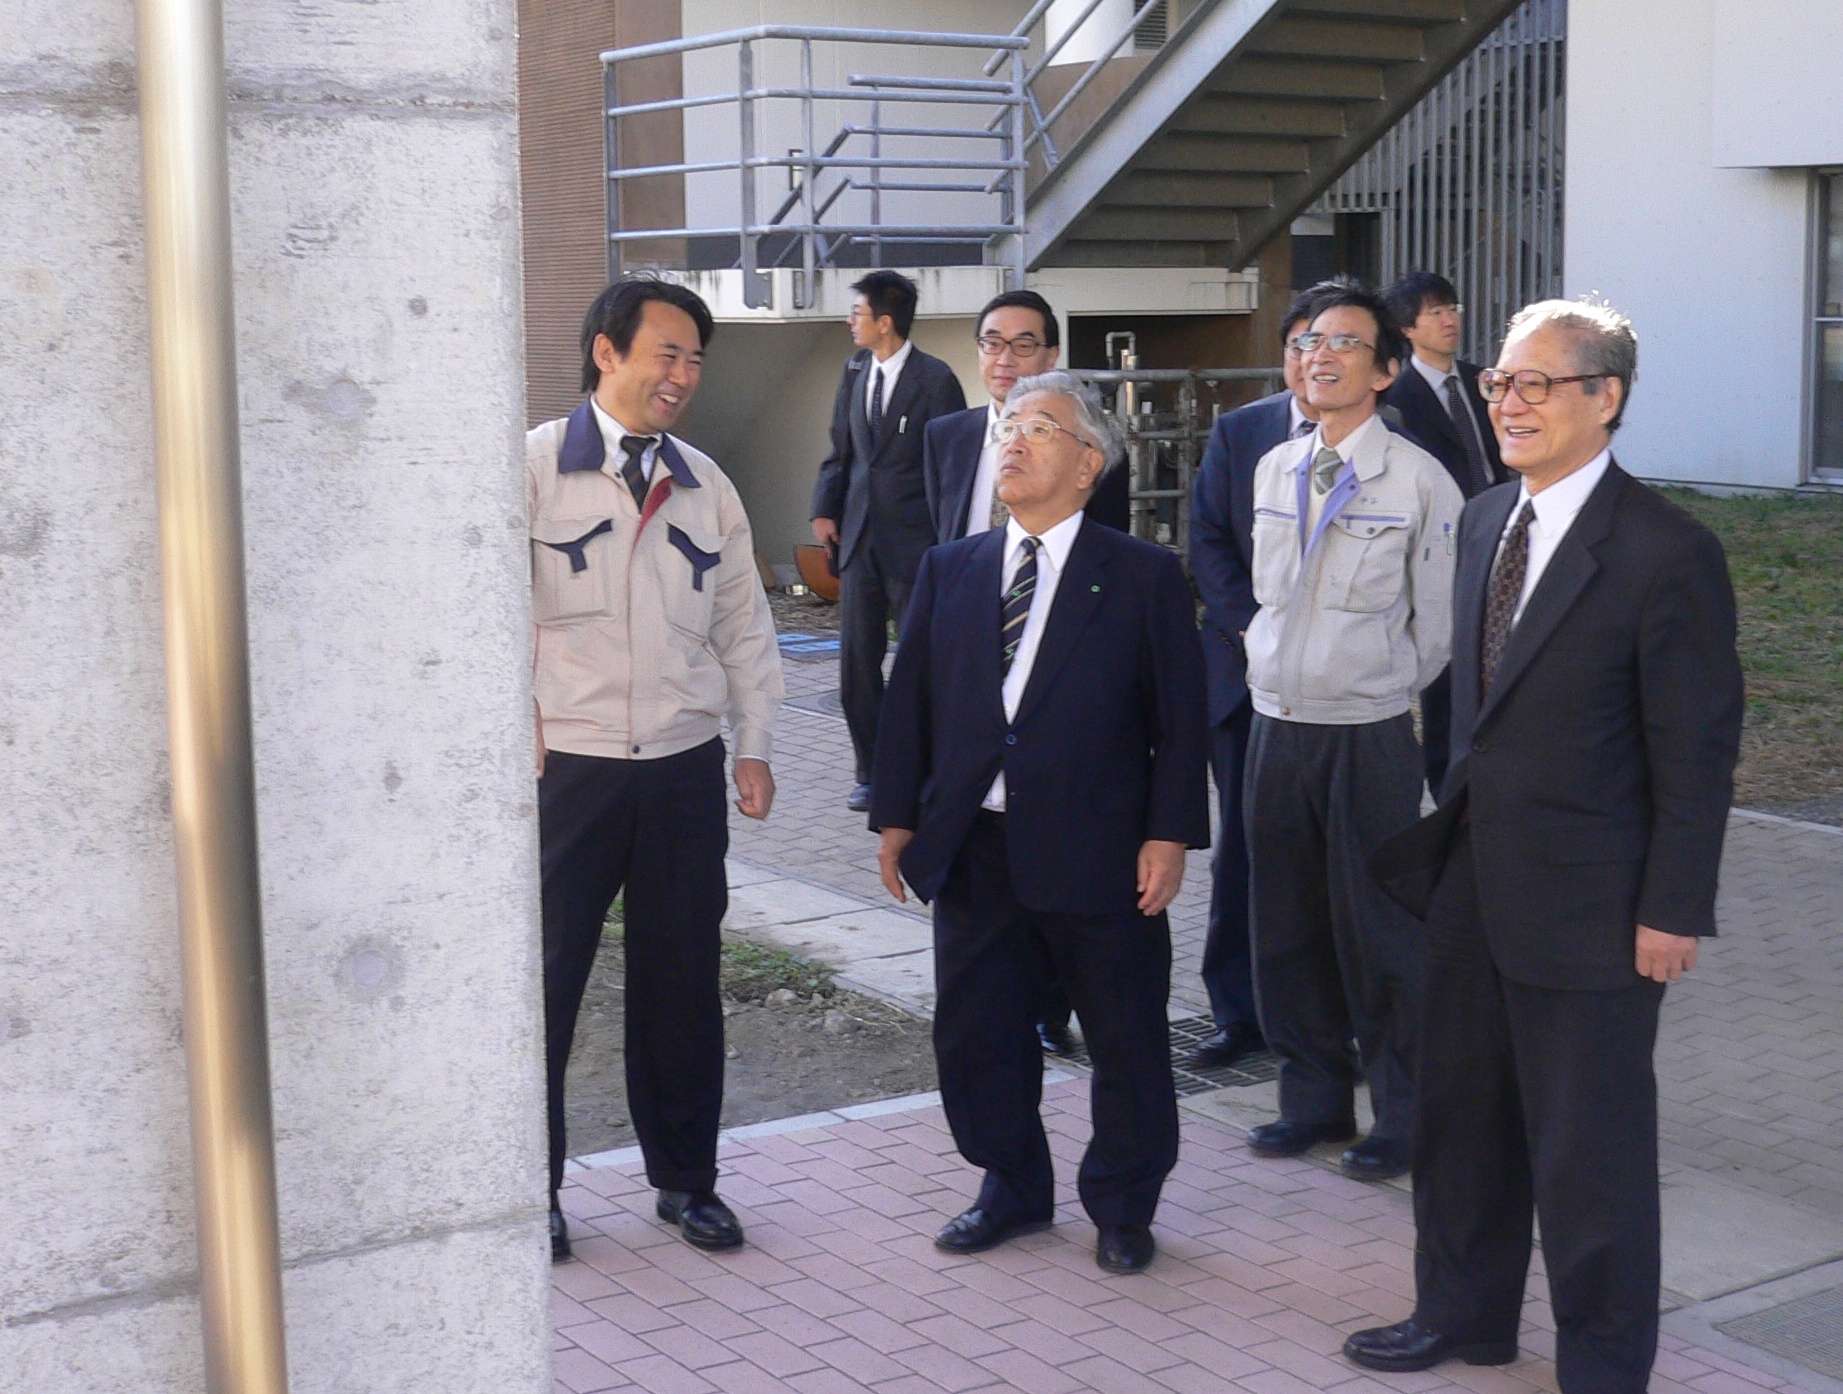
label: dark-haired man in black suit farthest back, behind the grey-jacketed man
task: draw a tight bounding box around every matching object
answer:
[1382,271,1506,798]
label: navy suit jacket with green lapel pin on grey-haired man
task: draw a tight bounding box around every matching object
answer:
[870,524,1209,915]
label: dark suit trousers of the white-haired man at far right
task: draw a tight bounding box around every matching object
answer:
[1414,832,1664,1394]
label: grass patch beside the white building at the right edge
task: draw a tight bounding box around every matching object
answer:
[1664,489,1843,808]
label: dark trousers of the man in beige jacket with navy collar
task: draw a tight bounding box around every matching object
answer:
[538,739,730,1193]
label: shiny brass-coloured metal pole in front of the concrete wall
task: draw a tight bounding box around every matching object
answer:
[136,0,288,1394]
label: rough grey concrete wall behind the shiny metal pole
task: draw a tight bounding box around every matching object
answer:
[0,0,549,1394]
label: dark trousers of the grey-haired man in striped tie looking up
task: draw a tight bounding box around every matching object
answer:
[934,813,1178,1224]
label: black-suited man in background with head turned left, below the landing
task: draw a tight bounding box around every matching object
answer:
[813,271,966,811]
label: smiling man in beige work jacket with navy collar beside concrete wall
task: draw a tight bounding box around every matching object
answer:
[525,278,781,1258]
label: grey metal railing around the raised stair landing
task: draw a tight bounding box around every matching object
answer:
[601,24,1028,308]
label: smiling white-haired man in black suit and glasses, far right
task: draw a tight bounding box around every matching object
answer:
[1345,301,1742,1394]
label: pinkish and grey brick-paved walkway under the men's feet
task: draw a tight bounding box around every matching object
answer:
[555,660,1843,1394]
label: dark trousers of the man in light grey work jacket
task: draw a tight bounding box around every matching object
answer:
[1246,712,1425,1141]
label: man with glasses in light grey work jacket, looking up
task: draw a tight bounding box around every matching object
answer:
[1244,289,1465,1180]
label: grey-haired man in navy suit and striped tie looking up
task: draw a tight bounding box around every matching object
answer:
[872,372,1209,1272]
